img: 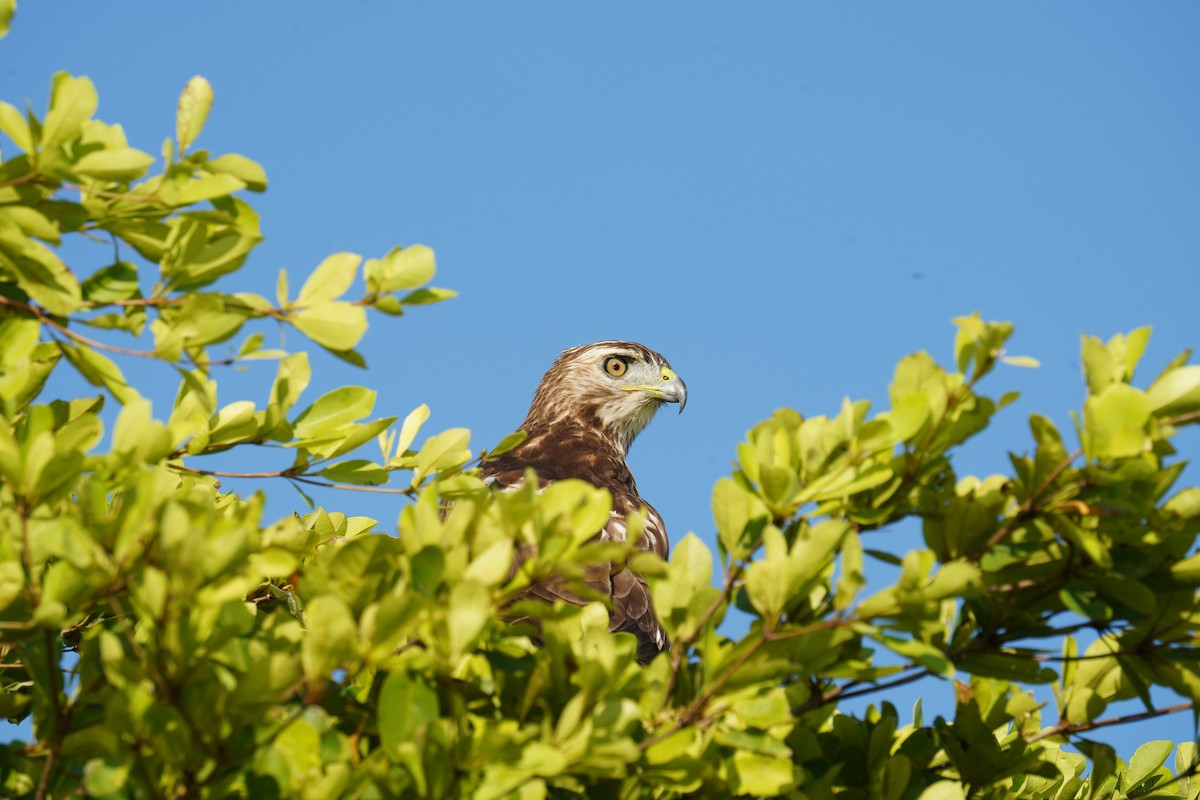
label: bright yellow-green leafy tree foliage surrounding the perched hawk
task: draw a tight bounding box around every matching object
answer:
[0,40,1200,800]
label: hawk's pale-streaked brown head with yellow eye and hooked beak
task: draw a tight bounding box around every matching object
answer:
[522,342,688,452]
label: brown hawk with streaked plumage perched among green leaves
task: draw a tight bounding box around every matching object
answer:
[484,342,688,663]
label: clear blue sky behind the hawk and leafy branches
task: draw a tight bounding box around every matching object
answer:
[7,0,1200,757]
